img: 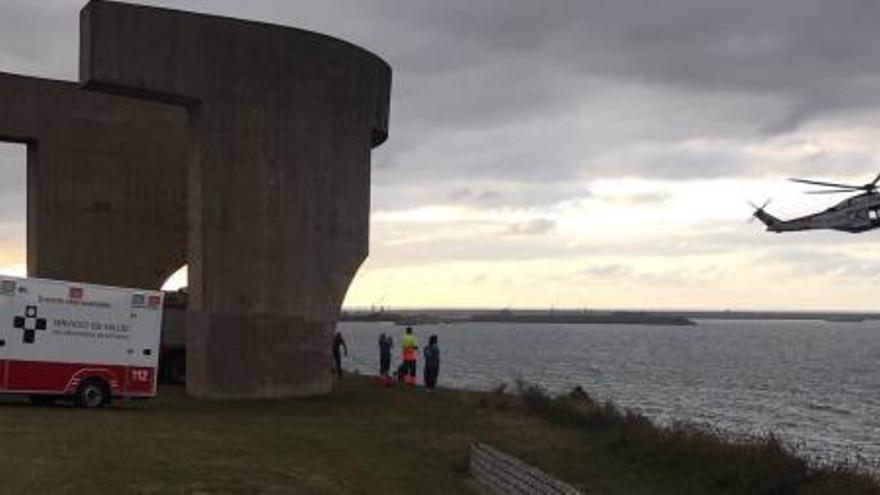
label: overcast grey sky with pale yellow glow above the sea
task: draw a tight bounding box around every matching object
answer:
[0,0,880,310]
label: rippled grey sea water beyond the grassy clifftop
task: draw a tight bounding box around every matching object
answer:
[339,320,880,464]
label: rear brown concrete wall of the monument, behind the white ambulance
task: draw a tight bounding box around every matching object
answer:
[0,73,186,288]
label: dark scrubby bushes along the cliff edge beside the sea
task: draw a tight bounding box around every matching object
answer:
[516,380,880,495]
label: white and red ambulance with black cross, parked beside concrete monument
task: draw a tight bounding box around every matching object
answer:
[0,276,163,408]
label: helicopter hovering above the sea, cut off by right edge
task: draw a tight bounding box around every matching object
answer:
[749,175,880,234]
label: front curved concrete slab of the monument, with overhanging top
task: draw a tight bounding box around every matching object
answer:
[80,1,391,398]
